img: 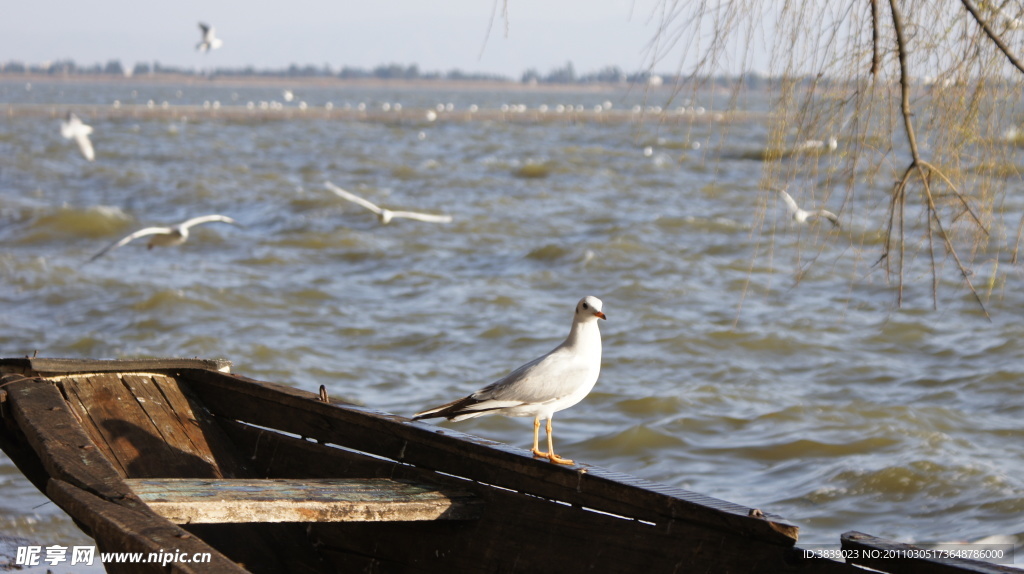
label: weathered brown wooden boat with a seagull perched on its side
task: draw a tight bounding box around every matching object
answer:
[0,358,1012,573]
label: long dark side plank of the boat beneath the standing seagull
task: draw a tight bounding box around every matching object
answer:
[182,371,798,546]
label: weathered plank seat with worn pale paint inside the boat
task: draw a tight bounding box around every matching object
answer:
[127,479,479,524]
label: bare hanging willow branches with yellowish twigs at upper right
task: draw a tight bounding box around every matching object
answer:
[650,0,1024,317]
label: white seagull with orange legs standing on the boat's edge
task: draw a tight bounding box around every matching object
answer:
[413,297,606,465]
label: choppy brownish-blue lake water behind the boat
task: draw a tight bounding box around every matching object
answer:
[0,81,1024,561]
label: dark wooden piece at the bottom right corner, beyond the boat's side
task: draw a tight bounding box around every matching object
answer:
[840,531,1021,574]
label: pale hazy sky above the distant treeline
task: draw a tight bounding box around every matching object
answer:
[0,0,700,79]
